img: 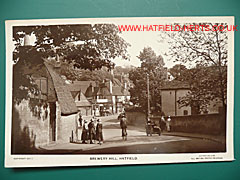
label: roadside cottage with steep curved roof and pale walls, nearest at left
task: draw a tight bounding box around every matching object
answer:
[12,60,78,153]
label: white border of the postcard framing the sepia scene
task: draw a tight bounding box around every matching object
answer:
[5,16,234,167]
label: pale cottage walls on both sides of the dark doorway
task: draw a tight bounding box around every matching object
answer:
[12,100,78,154]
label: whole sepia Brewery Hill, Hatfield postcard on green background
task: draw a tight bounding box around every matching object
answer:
[5,16,234,167]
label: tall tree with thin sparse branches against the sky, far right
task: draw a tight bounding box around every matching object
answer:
[165,23,228,112]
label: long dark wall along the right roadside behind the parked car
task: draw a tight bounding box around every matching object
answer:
[126,112,226,135]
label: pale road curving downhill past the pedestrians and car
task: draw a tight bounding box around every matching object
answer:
[42,116,225,154]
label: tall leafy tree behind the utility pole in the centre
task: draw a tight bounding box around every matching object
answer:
[129,47,166,112]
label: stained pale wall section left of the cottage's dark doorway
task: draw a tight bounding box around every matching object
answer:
[12,100,49,153]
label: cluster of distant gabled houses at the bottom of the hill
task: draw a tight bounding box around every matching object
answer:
[68,79,130,116]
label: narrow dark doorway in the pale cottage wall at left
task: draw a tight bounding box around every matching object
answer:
[49,102,56,142]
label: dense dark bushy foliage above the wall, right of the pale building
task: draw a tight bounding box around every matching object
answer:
[169,64,224,114]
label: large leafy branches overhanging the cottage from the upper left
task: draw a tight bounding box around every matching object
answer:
[13,24,129,102]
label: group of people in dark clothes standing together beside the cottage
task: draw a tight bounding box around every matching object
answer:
[79,116,103,145]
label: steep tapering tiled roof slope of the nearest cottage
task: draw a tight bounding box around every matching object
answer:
[44,62,78,115]
